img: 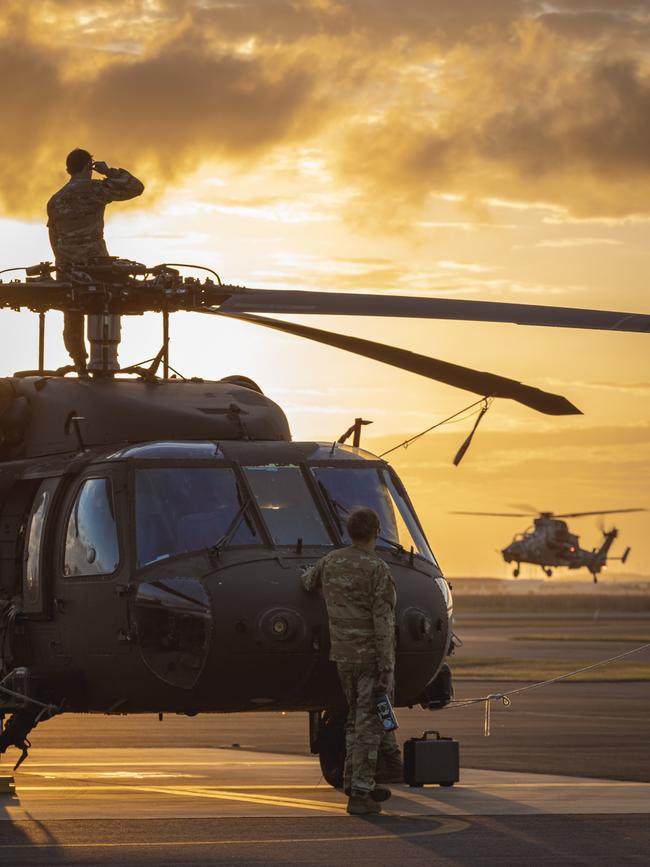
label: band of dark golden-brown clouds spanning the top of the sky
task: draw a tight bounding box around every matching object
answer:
[0,0,650,219]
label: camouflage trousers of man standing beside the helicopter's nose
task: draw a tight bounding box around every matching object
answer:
[336,662,382,793]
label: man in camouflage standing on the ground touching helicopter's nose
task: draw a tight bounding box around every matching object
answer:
[302,509,395,815]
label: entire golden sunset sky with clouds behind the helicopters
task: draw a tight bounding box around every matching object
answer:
[0,0,650,580]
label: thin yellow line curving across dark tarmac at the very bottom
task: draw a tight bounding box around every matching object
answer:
[0,818,469,850]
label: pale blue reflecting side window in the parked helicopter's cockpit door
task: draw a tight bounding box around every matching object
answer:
[63,479,120,577]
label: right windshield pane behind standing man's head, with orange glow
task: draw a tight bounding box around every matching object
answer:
[312,467,435,562]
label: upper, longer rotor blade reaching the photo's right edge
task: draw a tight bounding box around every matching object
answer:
[220,287,650,333]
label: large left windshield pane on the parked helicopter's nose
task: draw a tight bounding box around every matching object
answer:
[135,467,260,567]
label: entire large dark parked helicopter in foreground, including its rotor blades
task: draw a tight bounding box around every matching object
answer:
[0,259,650,785]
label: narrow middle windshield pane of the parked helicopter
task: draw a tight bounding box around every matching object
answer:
[246,464,332,545]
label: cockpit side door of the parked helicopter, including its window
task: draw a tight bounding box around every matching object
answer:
[57,465,130,683]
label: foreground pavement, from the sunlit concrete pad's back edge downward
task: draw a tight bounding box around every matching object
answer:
[0,747,650,865]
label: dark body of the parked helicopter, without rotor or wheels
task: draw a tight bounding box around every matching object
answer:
[0,379,452,714]
